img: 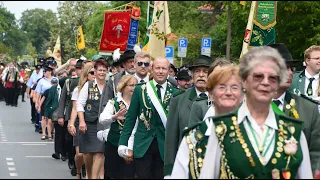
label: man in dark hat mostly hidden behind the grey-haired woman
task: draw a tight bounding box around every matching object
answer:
[269,44,320,174]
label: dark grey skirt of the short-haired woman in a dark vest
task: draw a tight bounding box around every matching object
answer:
[79,121,104,153]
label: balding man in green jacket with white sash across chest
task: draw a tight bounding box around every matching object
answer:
[118,58,180,179]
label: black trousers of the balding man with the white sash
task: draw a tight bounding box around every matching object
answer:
[134,137,164,179]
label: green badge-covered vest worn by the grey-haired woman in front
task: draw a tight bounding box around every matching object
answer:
[212,109,303,179]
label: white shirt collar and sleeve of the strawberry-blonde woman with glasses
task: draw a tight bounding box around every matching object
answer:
[170,106,215,179]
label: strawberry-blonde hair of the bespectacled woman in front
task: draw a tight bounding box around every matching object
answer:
[207,64,240,91]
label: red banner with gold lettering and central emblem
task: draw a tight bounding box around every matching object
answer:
[99,11,131,52]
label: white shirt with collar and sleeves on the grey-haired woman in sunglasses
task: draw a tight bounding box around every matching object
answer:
[200,103,313,179]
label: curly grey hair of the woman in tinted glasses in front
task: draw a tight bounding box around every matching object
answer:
[239,46,289,84]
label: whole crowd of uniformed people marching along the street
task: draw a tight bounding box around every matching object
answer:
[0,44,320,179]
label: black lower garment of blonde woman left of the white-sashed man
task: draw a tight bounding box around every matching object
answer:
[104,142,135,179]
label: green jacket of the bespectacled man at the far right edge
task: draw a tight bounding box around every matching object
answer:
[289,71,306,95]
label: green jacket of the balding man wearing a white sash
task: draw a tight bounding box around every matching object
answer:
[119,83,179,160]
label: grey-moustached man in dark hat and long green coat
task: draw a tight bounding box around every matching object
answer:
[164,55,212,176]
